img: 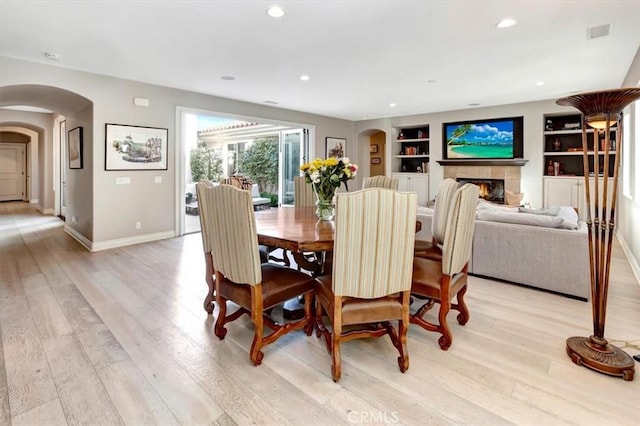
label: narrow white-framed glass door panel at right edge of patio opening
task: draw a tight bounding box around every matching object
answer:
[278,129,308,205]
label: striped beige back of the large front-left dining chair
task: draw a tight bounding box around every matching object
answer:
[201,185,262,285]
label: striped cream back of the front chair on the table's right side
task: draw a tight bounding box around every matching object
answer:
[442,183,478,275]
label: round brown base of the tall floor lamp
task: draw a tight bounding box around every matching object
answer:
[567,336,635,381]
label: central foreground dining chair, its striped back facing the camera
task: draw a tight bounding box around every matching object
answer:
[316,188,417,381]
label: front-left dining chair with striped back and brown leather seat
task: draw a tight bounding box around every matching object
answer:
[202,185,314,365]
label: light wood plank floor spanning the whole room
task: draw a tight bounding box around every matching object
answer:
[0,203,640,425]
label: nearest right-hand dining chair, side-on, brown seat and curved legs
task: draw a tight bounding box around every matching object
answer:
[411,184,478,350]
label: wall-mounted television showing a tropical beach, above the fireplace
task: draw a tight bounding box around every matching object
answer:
[442,117,523,160]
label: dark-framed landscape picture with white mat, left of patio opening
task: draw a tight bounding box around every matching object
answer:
[104,123,169,170]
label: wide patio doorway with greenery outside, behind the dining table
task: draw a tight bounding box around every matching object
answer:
[177,109,314,235]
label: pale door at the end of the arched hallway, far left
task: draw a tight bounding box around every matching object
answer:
[0,143,26,201]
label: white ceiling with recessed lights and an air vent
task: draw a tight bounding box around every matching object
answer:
[0,0,640,120]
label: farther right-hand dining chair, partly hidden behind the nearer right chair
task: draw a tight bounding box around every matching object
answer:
[414,178,458,261]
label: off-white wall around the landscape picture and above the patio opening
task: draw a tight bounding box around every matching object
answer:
[0,57,358,244]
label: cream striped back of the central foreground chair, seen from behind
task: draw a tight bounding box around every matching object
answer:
[332,188,418,299]
